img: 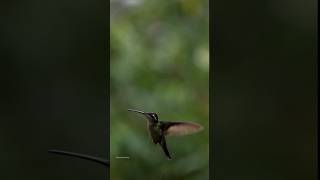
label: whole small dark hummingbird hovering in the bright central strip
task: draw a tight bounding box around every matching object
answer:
[128,109,203,159]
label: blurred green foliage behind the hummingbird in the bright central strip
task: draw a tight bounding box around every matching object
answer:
[110,0,209,180]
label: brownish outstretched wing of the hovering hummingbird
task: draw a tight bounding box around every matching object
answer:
[164,121,203,136]
